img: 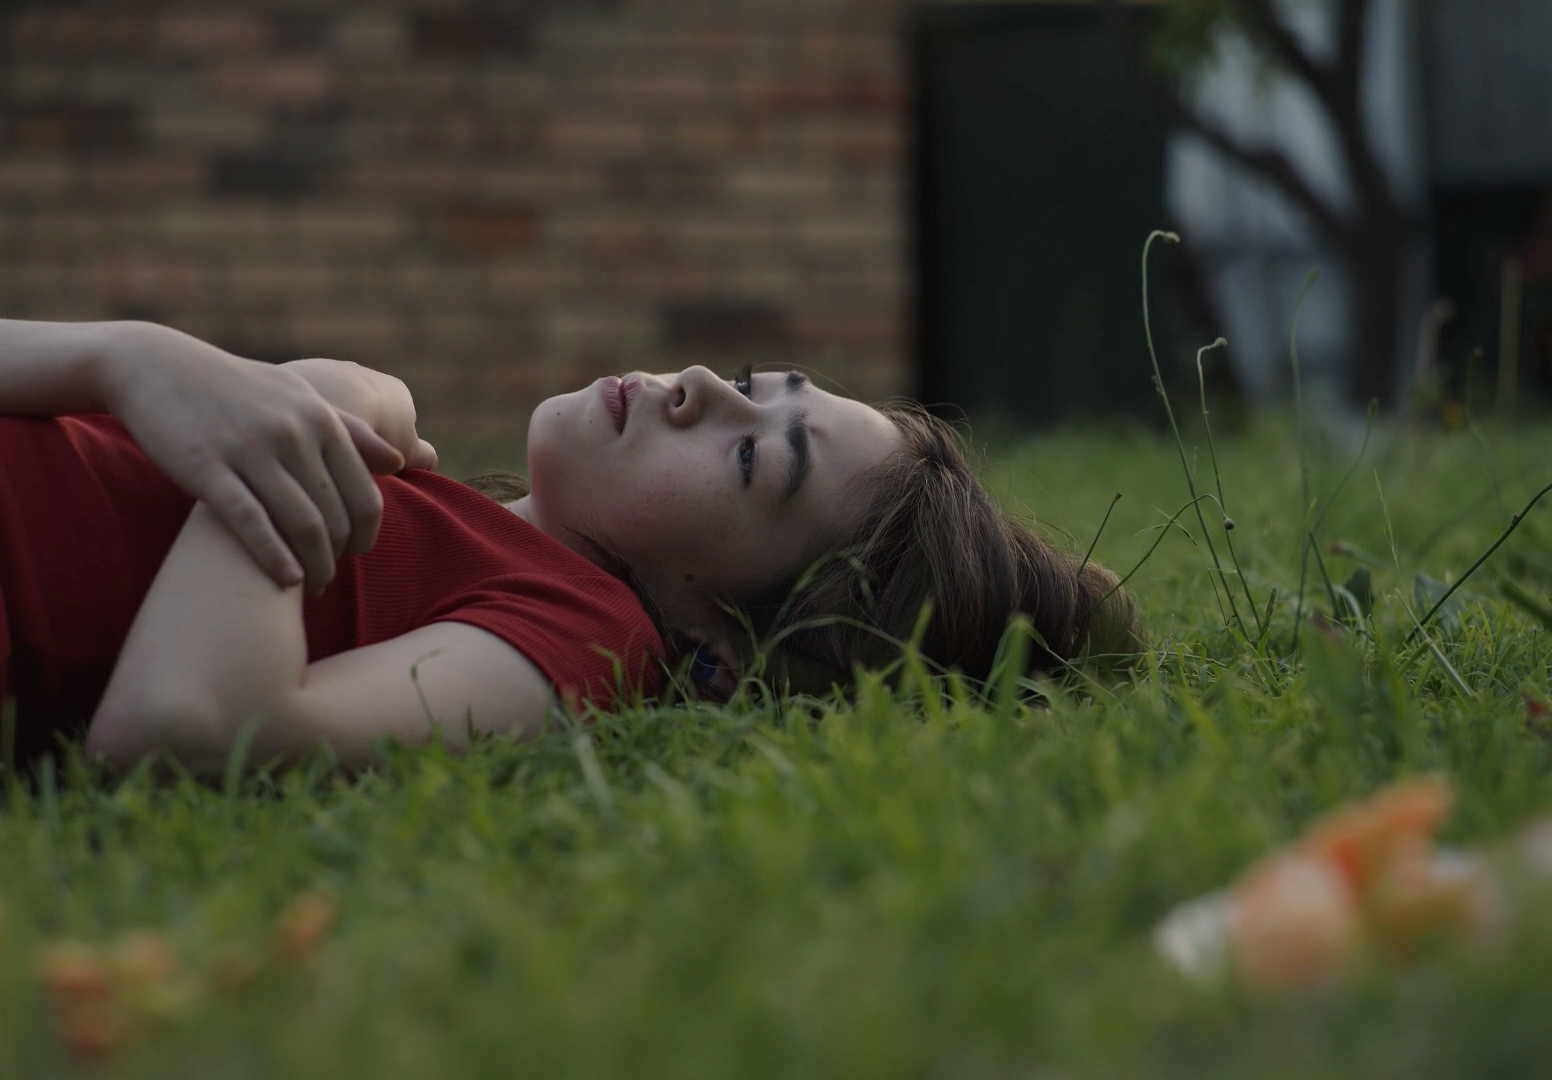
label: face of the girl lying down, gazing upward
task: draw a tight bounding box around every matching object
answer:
[526,366,900,605]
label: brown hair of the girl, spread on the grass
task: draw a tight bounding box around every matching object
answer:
[467,405,1144,694]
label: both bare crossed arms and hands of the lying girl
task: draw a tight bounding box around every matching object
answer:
[0,320,549,774]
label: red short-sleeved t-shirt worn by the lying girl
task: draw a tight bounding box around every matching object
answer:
[0,414,663,753]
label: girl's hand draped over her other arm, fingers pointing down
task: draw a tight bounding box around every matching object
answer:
[104,323,409,596]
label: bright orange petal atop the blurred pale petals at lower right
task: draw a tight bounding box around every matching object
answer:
[1299,776,1454,900]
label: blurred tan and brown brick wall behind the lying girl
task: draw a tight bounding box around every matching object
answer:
[0,0,909,438]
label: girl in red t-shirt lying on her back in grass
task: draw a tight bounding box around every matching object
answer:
[0,321,1139,774]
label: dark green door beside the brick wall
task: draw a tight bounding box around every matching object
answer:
[914,3,1164,422]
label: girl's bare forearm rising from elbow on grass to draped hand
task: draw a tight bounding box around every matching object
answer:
[87,503,307,776]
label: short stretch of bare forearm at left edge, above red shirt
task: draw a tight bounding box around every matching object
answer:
[0,318,130,416]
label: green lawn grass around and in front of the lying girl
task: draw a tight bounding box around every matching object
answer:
[0,402,1552,1078]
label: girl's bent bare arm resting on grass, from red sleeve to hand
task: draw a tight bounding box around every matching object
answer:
[87,504,549,776]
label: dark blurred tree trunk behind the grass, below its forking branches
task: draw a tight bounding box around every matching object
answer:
[1338,211,1406,408]
